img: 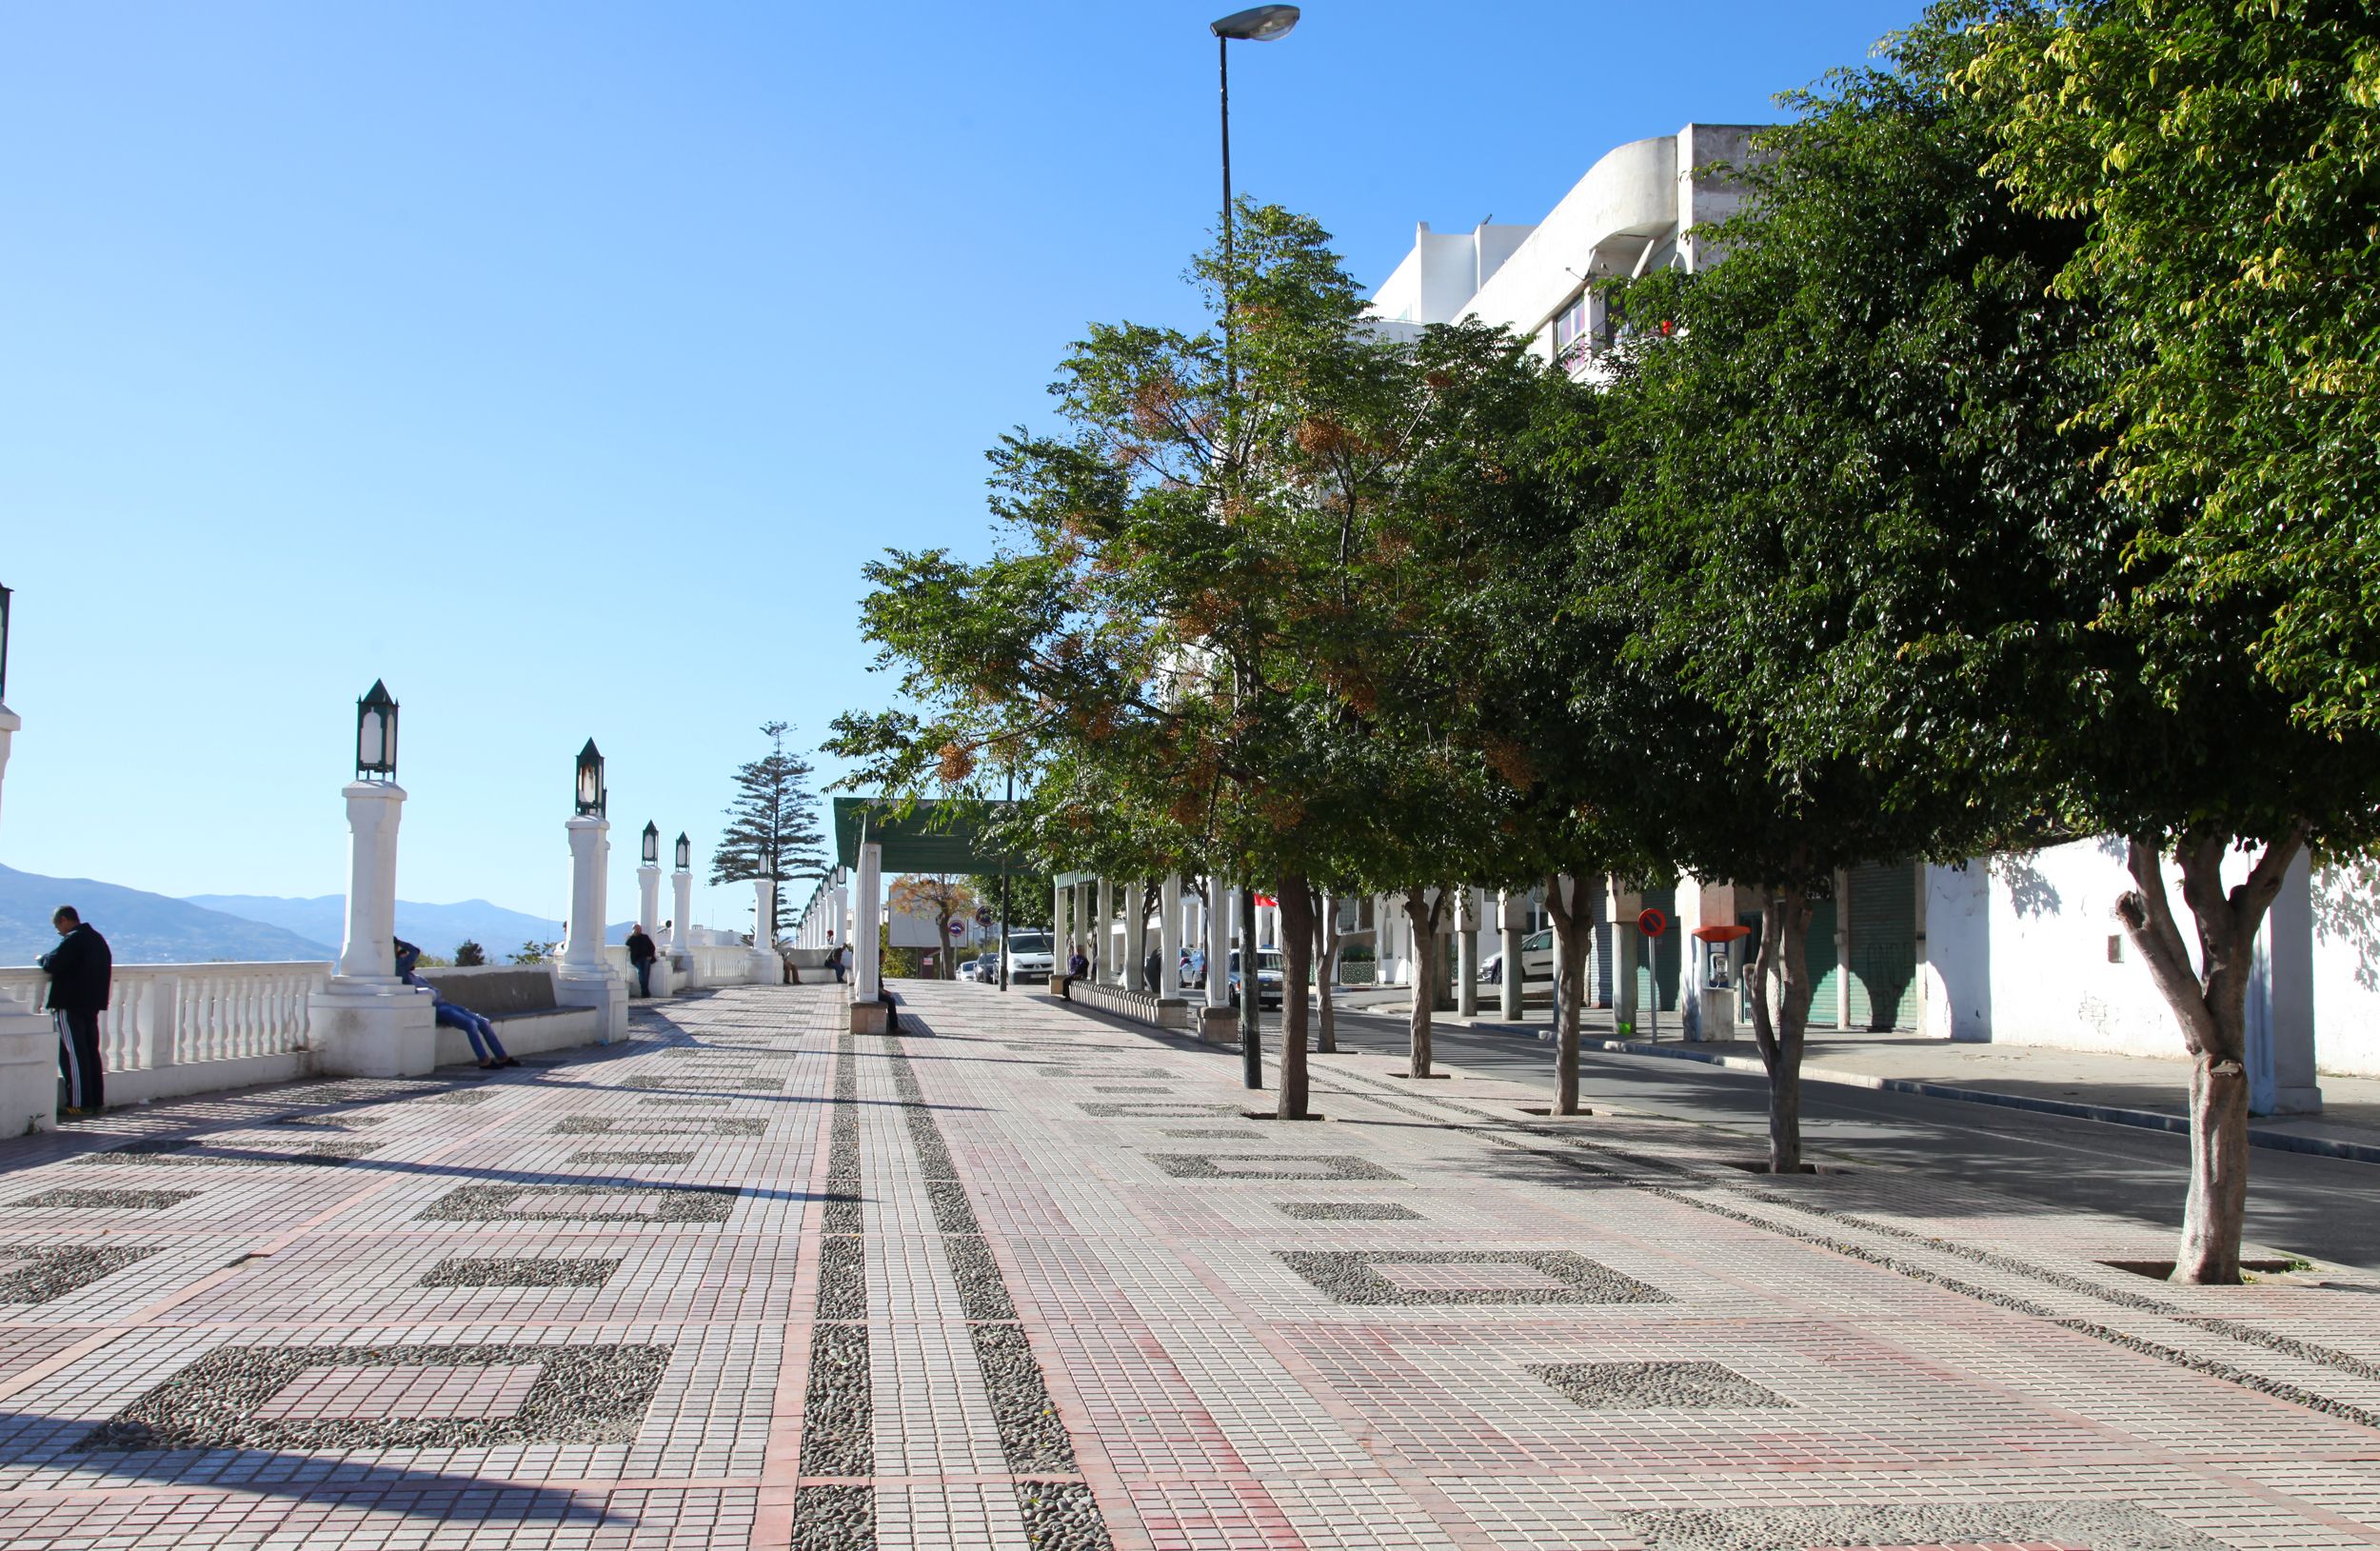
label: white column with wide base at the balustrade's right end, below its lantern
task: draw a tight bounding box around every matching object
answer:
[307,780,438,1078]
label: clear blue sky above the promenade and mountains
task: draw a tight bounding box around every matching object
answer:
[0,0,1916,923]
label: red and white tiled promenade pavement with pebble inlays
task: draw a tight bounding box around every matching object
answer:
[0,984,2380,1551]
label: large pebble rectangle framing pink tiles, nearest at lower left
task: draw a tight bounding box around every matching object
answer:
[81,1344,669,1449]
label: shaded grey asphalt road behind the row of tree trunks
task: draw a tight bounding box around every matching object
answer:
[1266,1008,2380,1270]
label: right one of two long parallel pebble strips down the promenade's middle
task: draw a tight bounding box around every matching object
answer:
[883,1035,1114,1551]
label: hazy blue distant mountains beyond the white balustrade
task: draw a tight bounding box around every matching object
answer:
[0,865,652,964]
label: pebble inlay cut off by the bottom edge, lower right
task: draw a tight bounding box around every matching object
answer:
[1621,1501,2223,1551]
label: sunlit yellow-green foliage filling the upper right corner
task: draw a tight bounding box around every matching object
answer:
[1959,0,2380,730]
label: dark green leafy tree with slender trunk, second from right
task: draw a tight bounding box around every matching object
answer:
[1578,14,2121,1170]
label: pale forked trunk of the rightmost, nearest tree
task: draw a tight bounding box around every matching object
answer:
[2116,825,2307,1284]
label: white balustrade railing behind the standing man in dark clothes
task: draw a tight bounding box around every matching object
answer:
[0,964,331,1070]
